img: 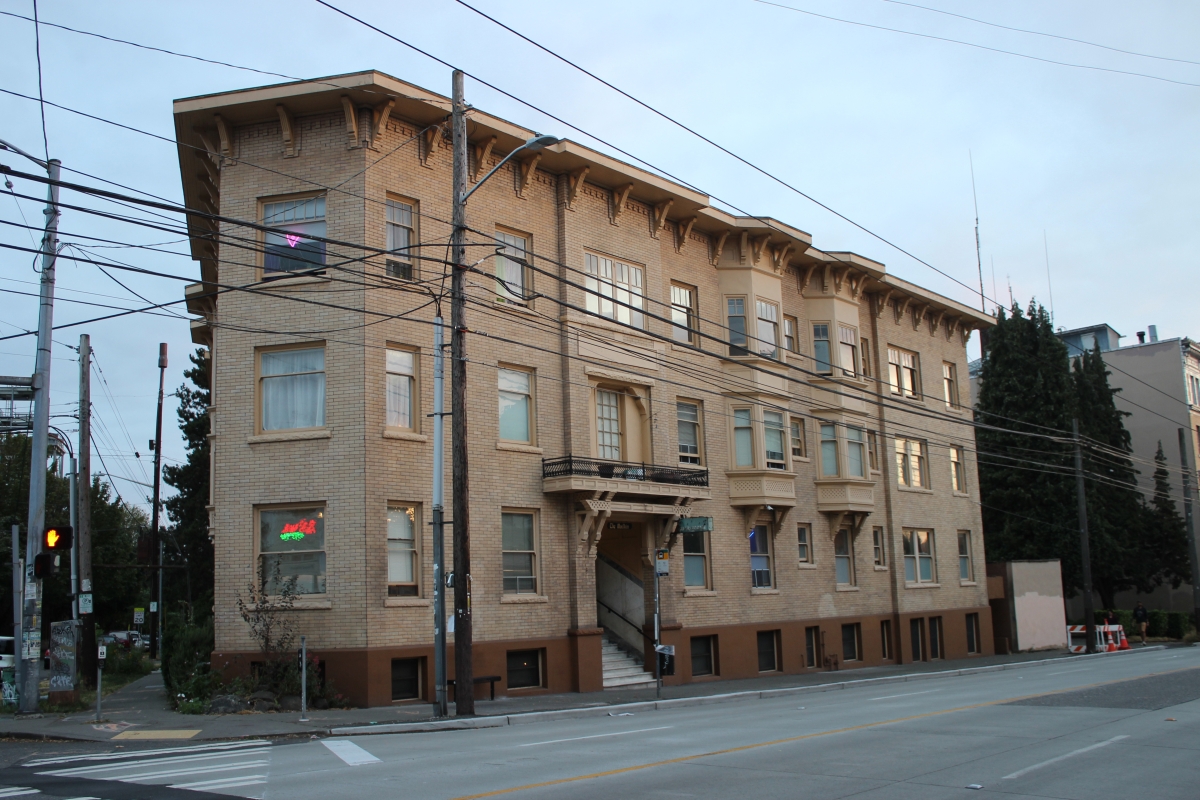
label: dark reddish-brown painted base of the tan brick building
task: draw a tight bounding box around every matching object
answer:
[212,606,994,706]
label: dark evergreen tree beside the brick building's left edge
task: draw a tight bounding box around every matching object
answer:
[162,348,214,620]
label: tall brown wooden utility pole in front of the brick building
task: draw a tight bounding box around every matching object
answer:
[450,70,475,716]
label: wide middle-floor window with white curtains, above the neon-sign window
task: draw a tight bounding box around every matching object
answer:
[259,347,325,431]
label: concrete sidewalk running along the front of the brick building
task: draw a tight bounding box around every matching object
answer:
[0,646,1162,744]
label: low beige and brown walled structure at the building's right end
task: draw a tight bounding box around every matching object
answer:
[988,559,1068,655]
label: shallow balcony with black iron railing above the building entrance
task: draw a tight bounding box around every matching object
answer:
[541,456,712,500]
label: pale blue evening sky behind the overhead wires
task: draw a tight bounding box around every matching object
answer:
[0,0,1200,510]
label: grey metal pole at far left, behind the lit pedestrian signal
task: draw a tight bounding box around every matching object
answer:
[20,158,60,714]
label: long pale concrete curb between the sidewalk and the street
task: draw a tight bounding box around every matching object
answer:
[329,644,1166,736]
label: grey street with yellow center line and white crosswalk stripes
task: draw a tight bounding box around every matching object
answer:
[0,648,1200,800]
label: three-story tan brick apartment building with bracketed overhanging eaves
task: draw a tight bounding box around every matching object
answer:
[174,72,991,705]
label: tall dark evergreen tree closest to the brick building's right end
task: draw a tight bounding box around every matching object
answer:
[976,302,1082,582]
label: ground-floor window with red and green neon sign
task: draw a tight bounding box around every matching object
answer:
[258,507,325,595]
